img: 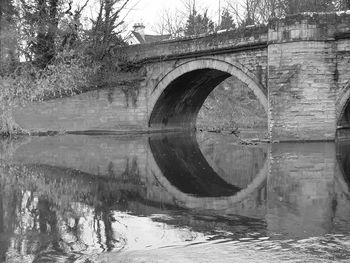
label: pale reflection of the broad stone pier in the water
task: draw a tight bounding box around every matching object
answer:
[267,143,337,238]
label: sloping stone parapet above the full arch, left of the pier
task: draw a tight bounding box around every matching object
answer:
[114,25,267,62]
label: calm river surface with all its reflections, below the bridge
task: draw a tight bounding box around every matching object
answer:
[0,134,350,263]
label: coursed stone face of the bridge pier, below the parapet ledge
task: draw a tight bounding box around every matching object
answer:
[269,41,336,141]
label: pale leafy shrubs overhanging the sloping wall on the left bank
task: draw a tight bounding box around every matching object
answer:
[0,51,99,135]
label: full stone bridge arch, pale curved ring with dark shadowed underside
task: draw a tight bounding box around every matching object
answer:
[148,58,268,129]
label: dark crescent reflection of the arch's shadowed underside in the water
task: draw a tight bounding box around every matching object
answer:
[149,134,241,196]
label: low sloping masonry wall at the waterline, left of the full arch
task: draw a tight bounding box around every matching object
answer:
[14,86,148,132]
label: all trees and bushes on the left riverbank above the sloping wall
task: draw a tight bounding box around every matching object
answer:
[0,0,129,136]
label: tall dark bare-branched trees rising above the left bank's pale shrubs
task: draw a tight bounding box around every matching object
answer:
[13,0,130,68]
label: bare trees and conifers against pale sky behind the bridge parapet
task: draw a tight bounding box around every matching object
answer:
[154,0,350,35]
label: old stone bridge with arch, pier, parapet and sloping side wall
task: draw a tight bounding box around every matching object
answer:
[15,13,350,141]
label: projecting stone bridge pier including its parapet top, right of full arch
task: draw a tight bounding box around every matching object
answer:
[268,13,350,141]
